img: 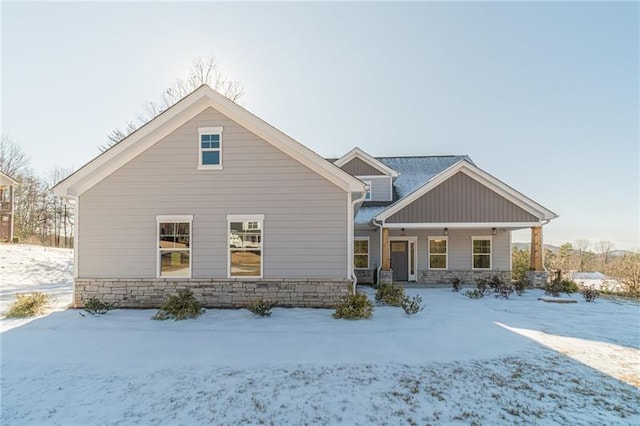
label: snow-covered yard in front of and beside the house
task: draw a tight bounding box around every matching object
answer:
[0,245,640,425]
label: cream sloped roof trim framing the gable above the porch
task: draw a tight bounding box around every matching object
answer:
[373,159,558,221]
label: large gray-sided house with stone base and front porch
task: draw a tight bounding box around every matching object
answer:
[54,85,555,307]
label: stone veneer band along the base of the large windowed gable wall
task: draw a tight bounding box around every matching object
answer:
[74,278,352,308]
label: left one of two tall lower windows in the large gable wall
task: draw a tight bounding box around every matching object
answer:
[156,215,193,278]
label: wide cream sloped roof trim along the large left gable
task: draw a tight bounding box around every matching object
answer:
[53,84,365,197]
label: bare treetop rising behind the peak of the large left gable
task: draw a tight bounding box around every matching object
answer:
[98,56,244,152]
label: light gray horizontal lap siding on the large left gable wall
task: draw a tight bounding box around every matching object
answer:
[78,108,348,279]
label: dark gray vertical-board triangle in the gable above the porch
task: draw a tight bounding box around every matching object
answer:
[387,172,539,223]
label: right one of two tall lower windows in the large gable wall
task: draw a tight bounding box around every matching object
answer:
[227,215,264,278]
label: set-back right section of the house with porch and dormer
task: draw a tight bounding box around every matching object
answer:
[334,148,557,283]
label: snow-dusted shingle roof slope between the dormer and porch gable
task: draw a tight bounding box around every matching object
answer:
[355,155,473,224]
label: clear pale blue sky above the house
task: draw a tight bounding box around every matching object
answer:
[1,2,640,249]
